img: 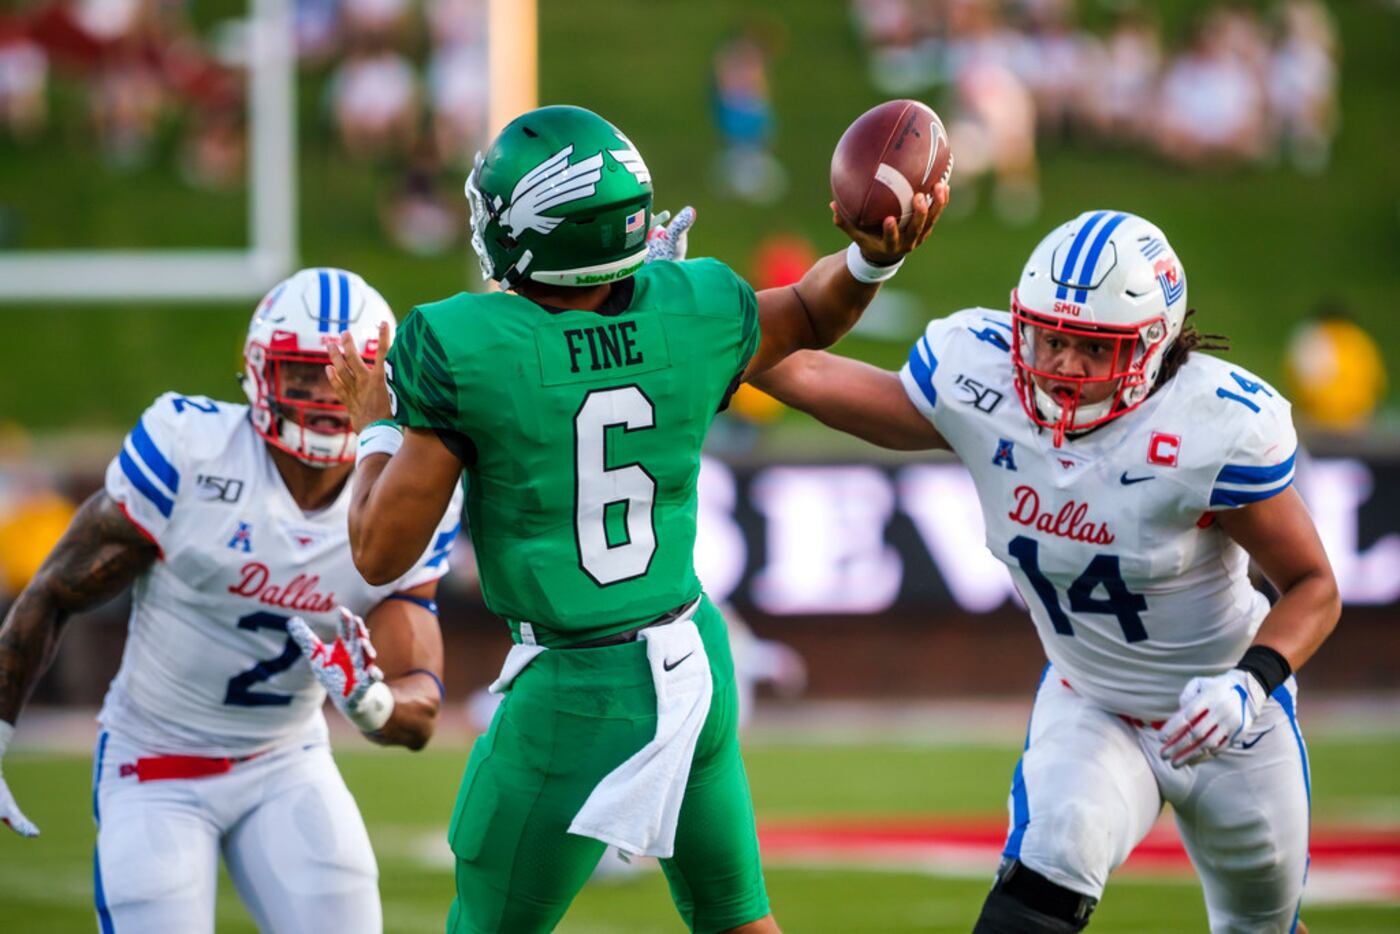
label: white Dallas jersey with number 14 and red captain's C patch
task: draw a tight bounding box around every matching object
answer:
[900,308,1298,721]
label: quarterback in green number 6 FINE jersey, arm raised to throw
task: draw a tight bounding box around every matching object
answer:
[332,106,948,934]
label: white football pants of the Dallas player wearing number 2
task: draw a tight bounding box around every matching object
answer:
[92,732,382,934]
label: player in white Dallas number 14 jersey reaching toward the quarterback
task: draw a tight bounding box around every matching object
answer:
[759,211,1340,933]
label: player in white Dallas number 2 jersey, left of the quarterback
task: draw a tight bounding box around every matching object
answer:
[0,269,461,934]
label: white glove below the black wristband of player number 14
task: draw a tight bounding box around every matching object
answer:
[1162,668,1268,769]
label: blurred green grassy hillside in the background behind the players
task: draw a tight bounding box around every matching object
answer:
[0,0,1400,430]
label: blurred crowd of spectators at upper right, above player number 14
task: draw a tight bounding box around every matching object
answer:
[851,0,1341,223]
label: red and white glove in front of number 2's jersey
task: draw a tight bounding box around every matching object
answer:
[287,606,393,732]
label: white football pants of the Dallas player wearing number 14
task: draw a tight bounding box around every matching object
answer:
[1005,665,1310,934]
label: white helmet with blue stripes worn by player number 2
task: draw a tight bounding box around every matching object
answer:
[241,269,395,468]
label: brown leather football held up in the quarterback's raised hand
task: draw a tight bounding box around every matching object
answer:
[832,101,953,232]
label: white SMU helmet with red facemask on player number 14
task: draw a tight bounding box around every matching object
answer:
[1011,210,1186,445]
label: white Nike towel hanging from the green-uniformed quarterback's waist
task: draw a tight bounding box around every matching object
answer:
[568,601,714,858]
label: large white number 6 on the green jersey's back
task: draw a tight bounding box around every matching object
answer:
[574,386,657,587]
